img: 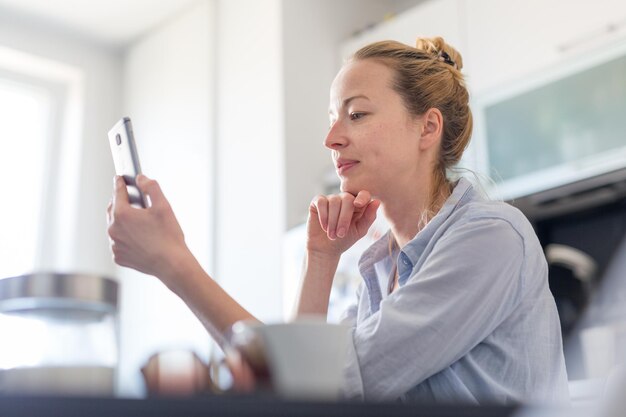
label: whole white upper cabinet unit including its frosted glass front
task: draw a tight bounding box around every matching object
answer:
[343,0,626,200]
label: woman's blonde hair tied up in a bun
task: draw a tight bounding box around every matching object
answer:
[350,37,473,222]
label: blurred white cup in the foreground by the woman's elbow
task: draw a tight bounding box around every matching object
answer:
[226,318,351,401]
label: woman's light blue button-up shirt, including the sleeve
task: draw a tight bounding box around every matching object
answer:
[342,179,569,404]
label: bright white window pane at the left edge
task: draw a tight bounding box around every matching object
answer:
[0,78,51,278]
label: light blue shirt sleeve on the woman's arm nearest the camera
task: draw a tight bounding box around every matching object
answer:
[344,218,524,400]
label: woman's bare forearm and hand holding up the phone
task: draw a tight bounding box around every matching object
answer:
[107,175,256,346]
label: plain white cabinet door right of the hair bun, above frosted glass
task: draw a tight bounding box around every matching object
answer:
[465,0,626,94]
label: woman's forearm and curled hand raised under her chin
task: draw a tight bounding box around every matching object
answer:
[296,191,380,317]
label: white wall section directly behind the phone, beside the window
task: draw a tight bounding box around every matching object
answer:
[119,0,215,396]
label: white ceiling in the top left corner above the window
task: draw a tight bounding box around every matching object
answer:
[0,0,197,46]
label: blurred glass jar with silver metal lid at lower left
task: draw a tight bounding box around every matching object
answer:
[0,273,119,396]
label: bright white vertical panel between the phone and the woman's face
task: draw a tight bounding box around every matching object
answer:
[215,0,285,321]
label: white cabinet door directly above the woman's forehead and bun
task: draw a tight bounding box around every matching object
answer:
[341,0,465,60]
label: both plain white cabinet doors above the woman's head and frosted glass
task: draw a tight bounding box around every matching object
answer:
[341,0,626,94]
